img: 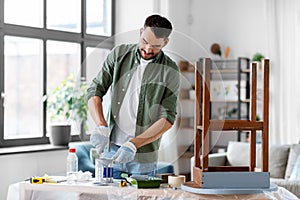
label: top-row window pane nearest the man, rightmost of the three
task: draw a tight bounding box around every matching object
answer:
[86,0,112,36]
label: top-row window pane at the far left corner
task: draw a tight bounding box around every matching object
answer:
[4,0,44,28]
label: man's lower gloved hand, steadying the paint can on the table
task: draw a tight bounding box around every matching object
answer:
[112,141,137,163]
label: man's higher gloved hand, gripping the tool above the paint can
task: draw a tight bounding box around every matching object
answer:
[90,126,110,153]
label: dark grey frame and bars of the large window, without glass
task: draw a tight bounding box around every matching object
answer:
[0,0,115,148]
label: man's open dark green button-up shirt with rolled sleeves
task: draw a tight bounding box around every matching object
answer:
[87,44,180,160]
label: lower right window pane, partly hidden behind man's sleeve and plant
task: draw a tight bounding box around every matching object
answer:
[86,47,110,134]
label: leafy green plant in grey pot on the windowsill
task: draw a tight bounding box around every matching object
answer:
[47,74,88,145]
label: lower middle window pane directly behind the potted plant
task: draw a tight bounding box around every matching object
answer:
[47,41,80,134]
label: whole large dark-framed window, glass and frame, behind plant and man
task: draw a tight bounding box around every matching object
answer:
[0,0,113,147]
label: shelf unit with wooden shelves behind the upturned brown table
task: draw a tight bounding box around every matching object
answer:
[179,57,250,153]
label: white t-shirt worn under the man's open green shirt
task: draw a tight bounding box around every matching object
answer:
[112,58,152,145]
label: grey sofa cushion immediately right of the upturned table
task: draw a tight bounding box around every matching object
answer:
[269,145,290,178]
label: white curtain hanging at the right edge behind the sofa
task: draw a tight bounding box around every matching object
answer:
[265,0,300,144]
